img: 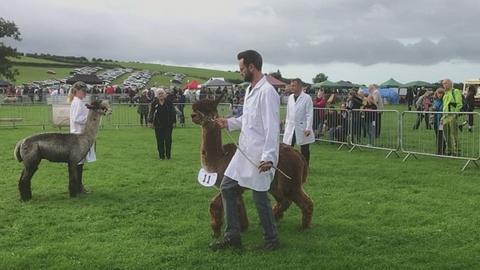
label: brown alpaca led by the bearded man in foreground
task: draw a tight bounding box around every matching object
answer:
[191,99,313,237]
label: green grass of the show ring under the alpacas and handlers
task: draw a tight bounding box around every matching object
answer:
[0,103,480,269]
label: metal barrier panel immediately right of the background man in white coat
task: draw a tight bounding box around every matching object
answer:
[313,108,349,150]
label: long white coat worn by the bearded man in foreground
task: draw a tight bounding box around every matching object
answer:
[225,76,280,191]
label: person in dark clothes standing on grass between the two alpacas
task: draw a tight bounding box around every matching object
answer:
[148,89,176,160]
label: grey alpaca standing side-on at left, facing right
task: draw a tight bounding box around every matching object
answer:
[14,101,110,201]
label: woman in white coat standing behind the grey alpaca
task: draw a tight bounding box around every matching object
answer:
[67,81,97,193]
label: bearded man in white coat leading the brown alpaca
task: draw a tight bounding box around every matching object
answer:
[210,50,280,250]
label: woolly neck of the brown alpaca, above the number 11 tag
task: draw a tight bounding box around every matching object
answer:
[202,124,223,167]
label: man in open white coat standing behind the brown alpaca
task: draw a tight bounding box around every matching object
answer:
[283,78,315,163]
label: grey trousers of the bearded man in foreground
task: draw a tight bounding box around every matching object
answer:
[220,176,278,242]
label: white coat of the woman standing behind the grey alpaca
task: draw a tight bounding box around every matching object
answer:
[70,97,97,164]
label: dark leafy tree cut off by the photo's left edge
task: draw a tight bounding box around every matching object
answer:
[0,18,21,81]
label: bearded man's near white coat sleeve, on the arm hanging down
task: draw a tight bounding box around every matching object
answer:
[260,88,280,165]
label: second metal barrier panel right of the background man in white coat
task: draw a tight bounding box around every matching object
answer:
[348,110,400,158]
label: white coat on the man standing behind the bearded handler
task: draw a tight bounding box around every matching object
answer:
[283,92,315,145]
